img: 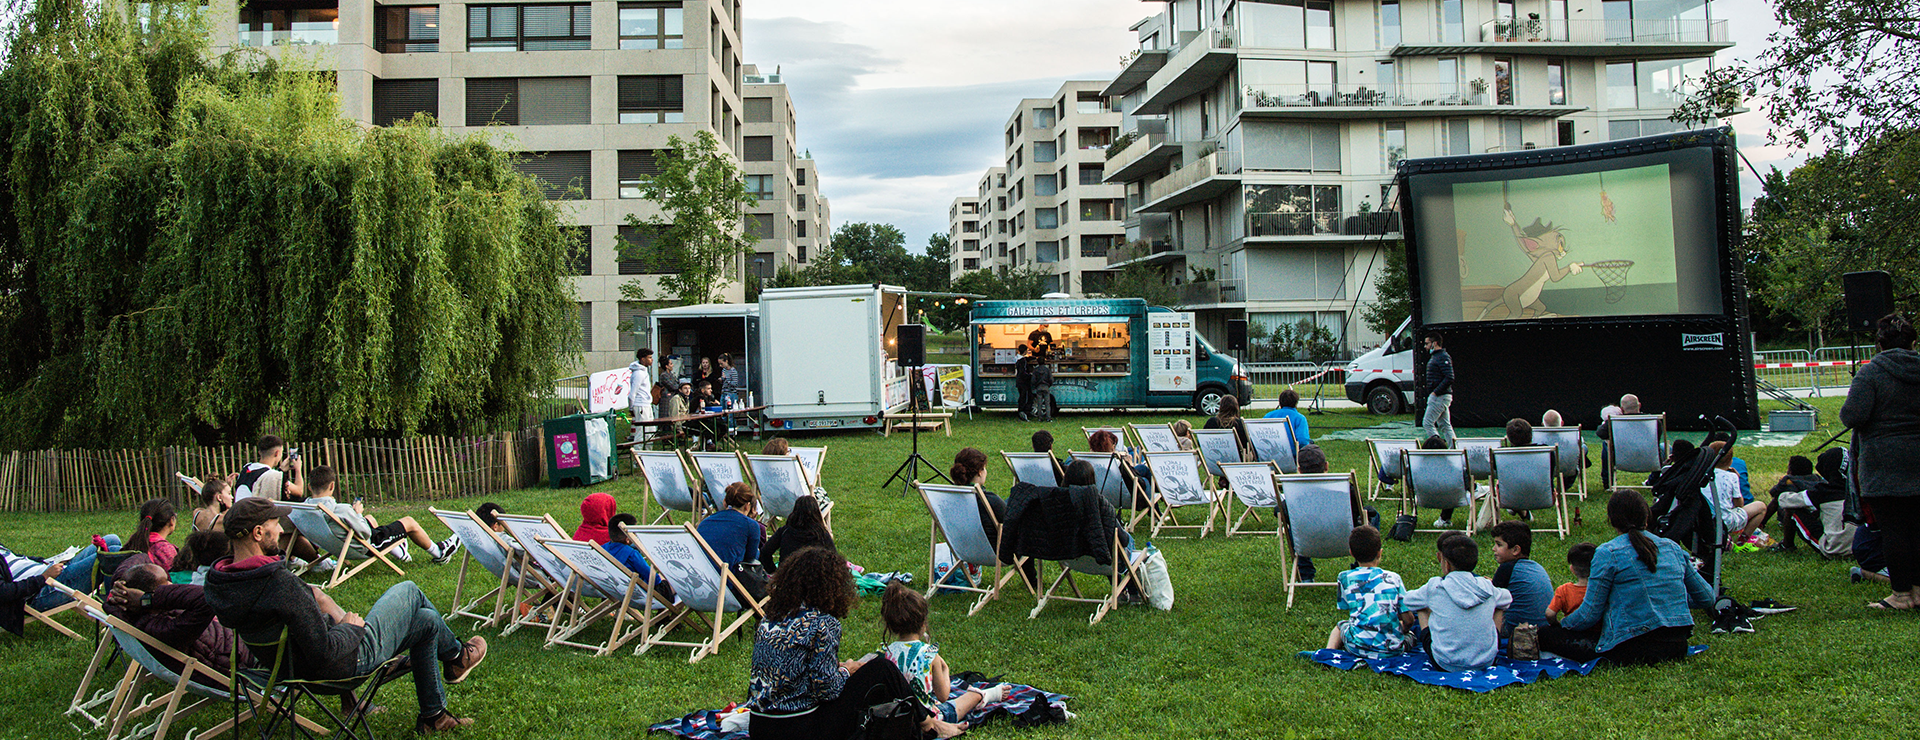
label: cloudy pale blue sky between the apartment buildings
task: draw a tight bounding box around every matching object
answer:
[743,0,1797,252]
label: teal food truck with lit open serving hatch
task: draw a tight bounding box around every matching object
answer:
[970,298,1254,415]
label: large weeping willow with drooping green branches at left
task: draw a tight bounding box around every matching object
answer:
[0,0,578,448]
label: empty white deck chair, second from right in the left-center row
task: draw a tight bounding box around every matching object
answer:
[540,540,674,655]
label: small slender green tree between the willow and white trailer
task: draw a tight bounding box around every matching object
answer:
[618,131,756,306]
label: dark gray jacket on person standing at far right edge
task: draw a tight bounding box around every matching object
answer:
[1839,350,1920,498]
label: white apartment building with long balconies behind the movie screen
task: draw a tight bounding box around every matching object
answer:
[1102,0,1732,350]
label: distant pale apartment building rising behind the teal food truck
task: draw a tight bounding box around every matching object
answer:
[948,81,1127,296]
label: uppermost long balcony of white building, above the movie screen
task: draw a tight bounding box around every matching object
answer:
[1392,17,1734,60]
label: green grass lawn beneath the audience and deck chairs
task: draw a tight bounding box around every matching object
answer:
[0,400,1920,740]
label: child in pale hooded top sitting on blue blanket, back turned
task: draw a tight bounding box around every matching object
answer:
[1400,530,1513,671]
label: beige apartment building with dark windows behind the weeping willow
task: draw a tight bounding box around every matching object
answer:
[207,0,826,369]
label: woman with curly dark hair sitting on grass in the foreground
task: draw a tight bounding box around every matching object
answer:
[747,548,966,740]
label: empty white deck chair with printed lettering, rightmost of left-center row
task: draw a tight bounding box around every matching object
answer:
[626,523,766,663]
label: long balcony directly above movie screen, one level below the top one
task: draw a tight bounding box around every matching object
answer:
[1240,83,1586,119]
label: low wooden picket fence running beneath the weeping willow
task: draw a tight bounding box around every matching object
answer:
[0,427,545,511]
